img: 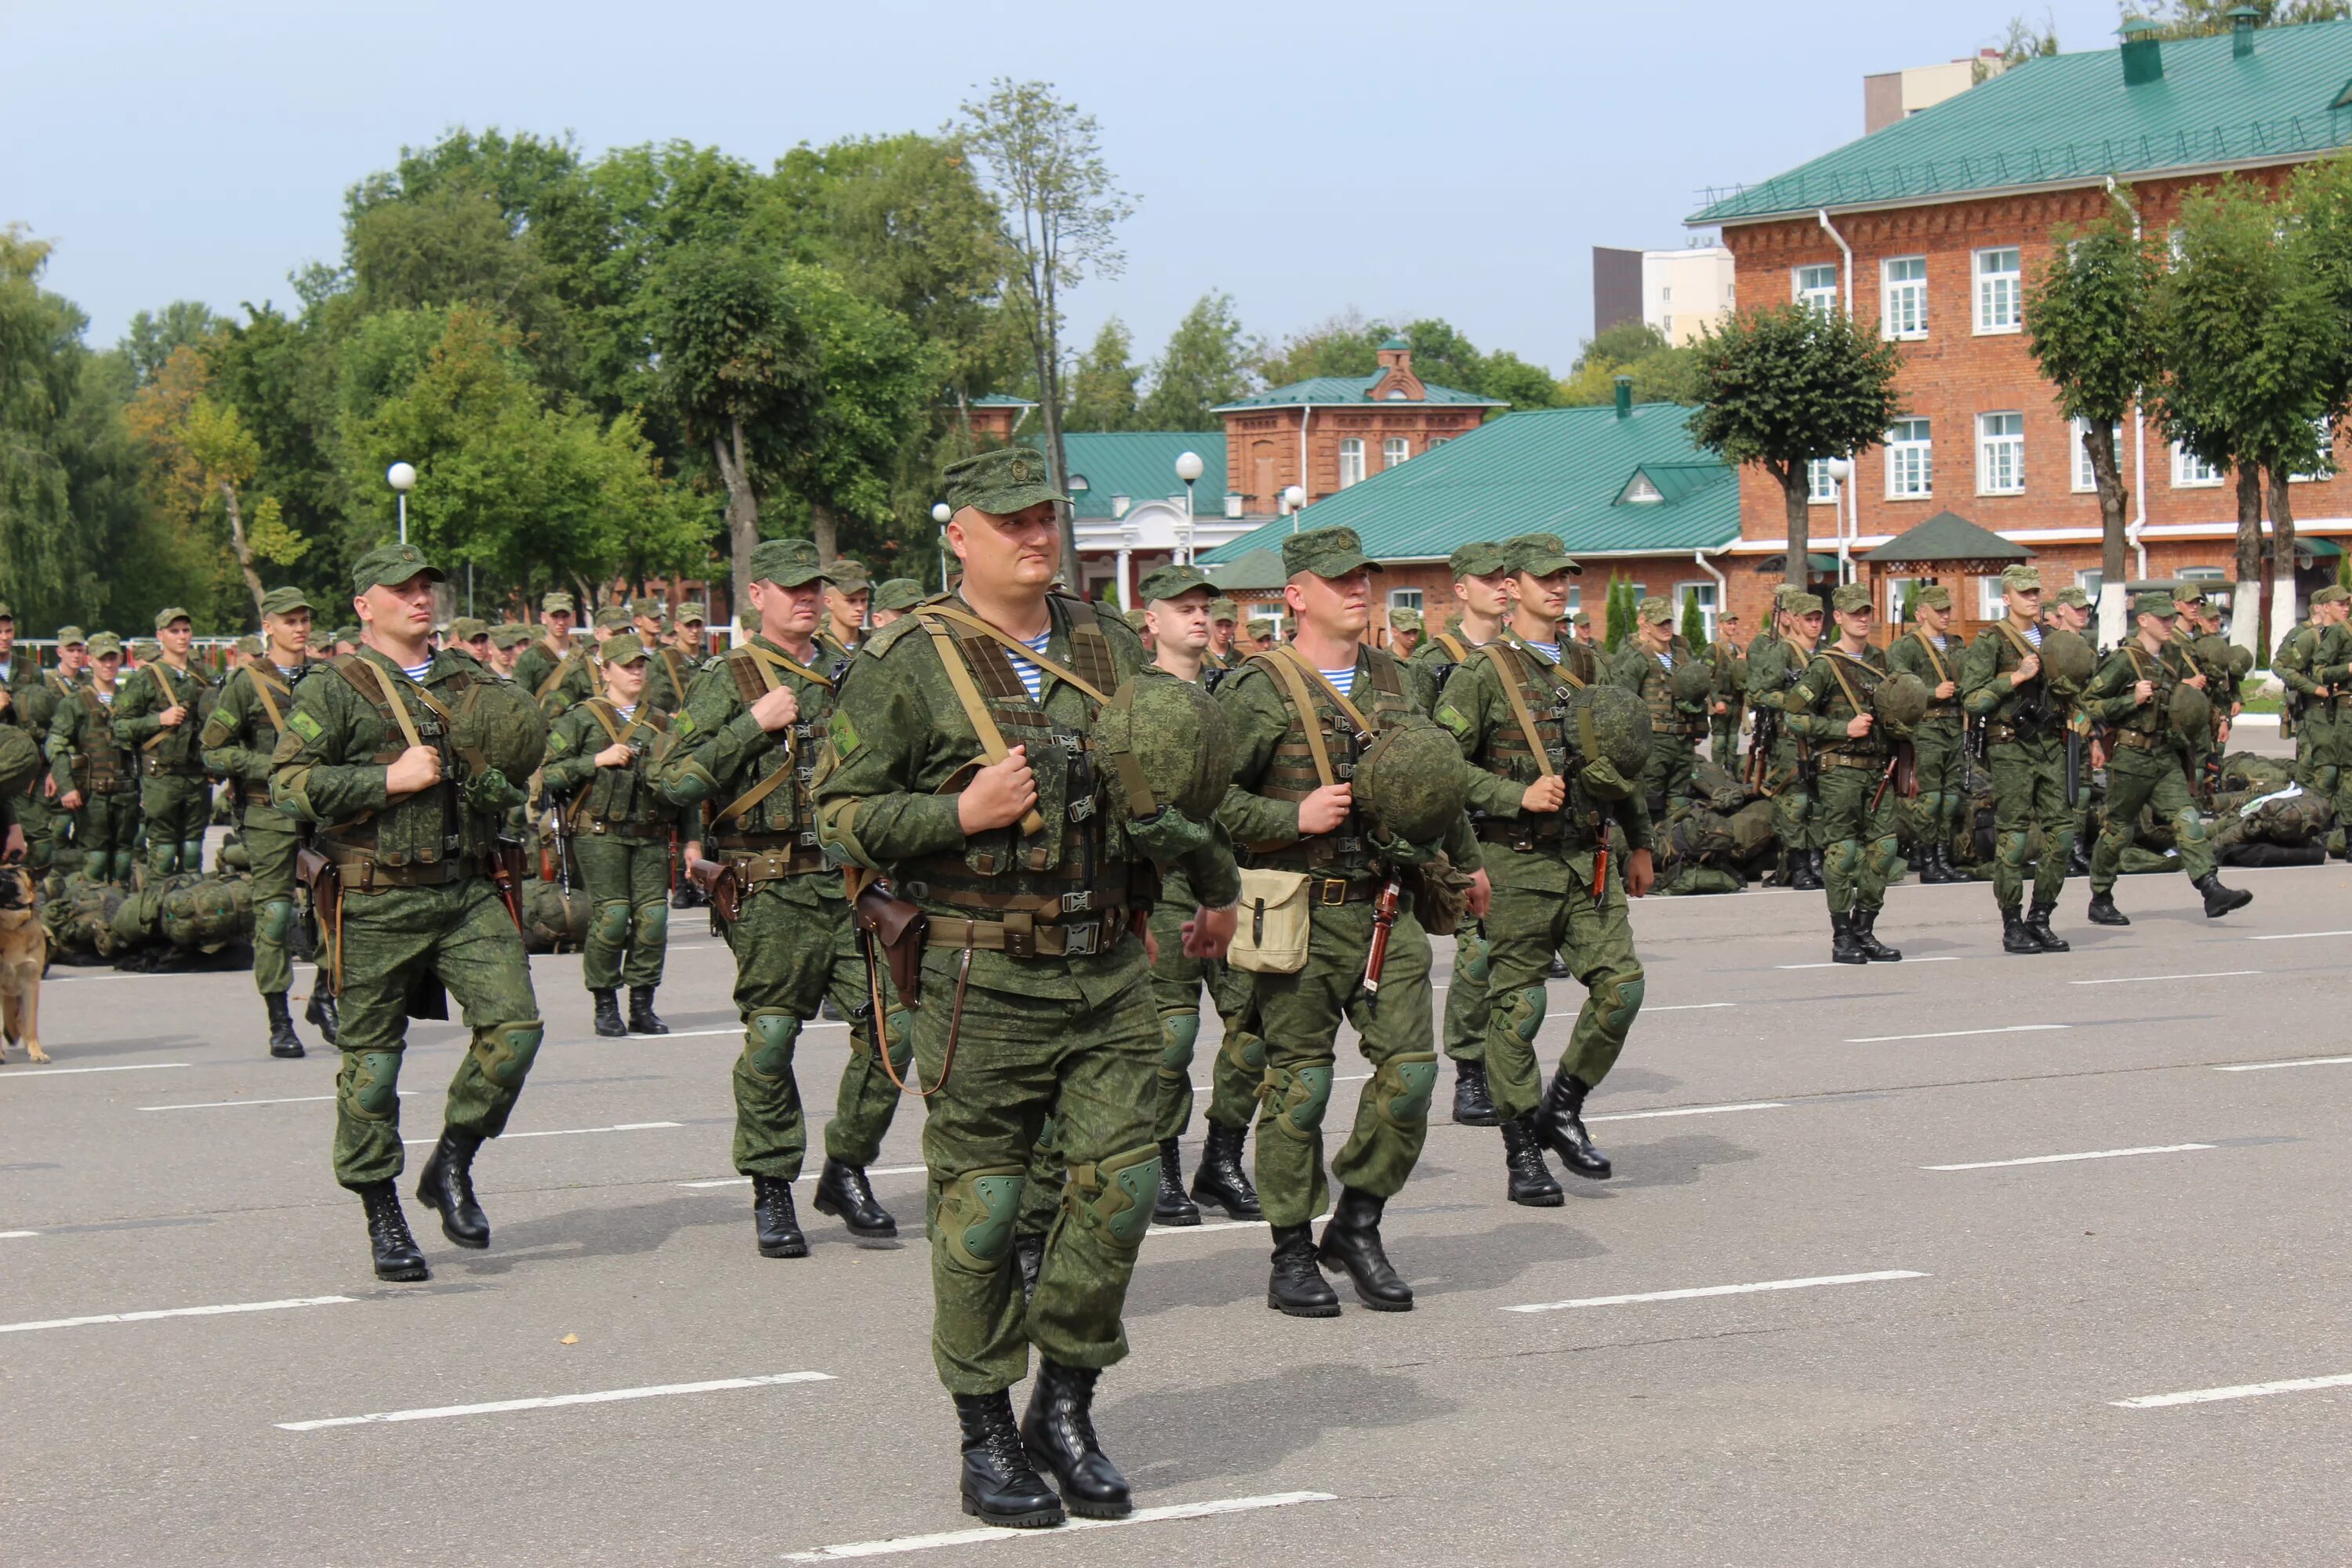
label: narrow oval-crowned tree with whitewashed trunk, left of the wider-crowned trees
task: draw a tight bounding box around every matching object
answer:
[2025,214,2161,642]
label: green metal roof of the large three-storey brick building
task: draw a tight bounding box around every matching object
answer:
[1686,21,2352,226]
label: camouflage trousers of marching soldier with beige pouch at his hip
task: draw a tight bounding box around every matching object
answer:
[1254,902,1430,1225]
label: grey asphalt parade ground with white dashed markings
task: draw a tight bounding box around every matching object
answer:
[0,846,2352,1568]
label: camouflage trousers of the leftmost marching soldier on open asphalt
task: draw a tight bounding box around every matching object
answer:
[334,877,541,1187]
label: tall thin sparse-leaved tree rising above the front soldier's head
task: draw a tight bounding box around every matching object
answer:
[960,78,1134,572]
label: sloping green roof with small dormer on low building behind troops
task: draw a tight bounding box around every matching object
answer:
[1204,402,1740,562]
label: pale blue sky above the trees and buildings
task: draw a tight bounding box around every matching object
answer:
[0,0,2117,374]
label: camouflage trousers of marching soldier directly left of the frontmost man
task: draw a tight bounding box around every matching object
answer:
[720,860,903,1180]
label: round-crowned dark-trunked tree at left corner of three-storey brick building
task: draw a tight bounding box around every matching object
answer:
[1691,303,1903,588]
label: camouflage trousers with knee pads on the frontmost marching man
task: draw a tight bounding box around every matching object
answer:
[913,942,1162,1394]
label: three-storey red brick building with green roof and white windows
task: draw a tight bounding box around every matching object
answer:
[1691,24,2352,626]
